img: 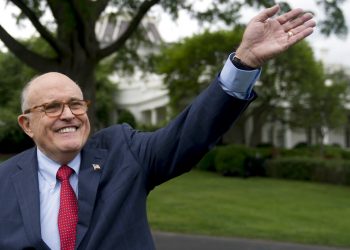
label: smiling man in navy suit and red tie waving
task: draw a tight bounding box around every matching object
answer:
[0,6,315,249]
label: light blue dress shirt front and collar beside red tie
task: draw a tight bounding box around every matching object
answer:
[37,149,80,250]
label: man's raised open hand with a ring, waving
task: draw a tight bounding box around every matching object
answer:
[236,5,316,68]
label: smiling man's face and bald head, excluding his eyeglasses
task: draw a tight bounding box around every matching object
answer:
[18,73,90,164]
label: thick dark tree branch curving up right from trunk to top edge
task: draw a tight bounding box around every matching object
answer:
[97,0,160,60]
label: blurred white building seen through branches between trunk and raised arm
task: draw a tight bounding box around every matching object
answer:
[96,14,169,125]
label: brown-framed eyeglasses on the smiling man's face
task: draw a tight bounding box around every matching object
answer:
[23,100,90,117]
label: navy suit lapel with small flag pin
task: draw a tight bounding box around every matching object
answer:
[76,148,107,249]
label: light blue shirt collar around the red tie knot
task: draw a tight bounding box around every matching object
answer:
[37,148,81,185]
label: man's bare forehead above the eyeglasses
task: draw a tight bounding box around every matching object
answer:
[27,73,83,103]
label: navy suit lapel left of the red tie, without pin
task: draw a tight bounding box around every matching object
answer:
[12,149,48,249]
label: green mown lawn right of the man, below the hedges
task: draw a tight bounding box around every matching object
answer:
[148,170,350,247]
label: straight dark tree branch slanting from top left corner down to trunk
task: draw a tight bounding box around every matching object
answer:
[10,0,63,54]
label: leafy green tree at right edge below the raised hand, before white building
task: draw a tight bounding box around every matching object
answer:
[289,64,350,143]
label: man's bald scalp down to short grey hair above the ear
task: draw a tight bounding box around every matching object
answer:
[21,72,83,112]
